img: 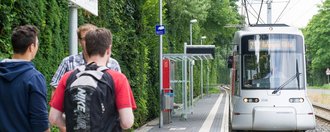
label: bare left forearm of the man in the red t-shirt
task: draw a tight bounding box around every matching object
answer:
[49,107,66,132]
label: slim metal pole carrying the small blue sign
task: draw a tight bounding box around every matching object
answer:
[159,0,163,128]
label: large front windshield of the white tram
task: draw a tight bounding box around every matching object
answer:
[241,34,305,90]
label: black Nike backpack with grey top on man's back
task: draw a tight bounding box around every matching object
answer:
[64,63,121,132]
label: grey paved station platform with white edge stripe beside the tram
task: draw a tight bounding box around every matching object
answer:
[134,90,229,132]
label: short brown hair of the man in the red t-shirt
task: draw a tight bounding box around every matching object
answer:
[85,28,112,57]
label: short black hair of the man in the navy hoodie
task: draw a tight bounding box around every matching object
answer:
[11,25,39,54]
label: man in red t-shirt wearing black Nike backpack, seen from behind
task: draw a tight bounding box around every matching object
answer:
[49,28,136,132]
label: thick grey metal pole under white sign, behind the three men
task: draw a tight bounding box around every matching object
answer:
[69,2,78,55]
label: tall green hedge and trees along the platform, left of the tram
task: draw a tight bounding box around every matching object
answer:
[0,0,240,130]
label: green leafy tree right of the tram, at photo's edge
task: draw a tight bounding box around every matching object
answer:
[304,0,330,85]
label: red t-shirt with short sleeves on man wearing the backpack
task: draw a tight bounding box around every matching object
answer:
[49,70,136,112]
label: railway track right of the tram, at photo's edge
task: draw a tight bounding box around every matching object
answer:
[313,103,330,123]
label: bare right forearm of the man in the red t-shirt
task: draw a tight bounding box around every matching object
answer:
[119,108,134,129]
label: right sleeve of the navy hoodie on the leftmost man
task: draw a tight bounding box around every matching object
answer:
[28,74,49,131]
